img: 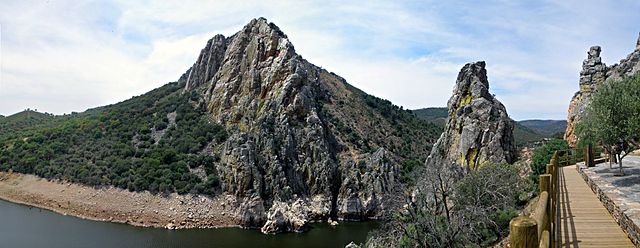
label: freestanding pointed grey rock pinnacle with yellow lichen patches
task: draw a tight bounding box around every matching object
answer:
[427,61,517,169]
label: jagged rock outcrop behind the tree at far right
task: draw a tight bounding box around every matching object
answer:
[564,34,640,146]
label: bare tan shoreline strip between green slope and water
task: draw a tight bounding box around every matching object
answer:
[0,172,242,229]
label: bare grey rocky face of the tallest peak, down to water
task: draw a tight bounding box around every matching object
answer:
[180,18,437,233]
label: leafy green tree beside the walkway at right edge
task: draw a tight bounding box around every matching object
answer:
[576,74,640,175]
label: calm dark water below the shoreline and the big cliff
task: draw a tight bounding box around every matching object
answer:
[0,200,378,248]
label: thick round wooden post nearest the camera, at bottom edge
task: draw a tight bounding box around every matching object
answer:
[509,216,540,248]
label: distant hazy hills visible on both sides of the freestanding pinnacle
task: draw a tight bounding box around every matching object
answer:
[412,107,567,146]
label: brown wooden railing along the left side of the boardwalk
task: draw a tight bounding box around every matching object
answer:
[509,145,607,248]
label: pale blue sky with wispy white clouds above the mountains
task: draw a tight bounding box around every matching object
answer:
[0,0,640,120]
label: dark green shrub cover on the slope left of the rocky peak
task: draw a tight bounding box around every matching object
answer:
[0,83,227,194]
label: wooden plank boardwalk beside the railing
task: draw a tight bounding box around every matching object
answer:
[556,165,635,247]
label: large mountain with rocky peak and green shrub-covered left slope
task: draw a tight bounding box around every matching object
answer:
[0,18,440,233]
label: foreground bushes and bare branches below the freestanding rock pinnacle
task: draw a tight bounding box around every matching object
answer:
[367,163,528,247]
